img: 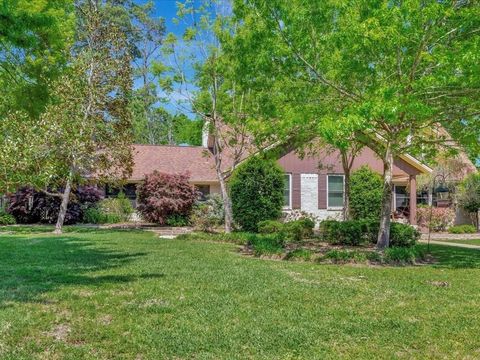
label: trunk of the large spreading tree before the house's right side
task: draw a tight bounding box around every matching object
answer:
[377,144,393,250]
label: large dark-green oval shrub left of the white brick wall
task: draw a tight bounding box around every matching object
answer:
[229,157,285,232]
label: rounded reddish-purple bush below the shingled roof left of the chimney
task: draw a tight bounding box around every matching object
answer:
[137,171,199,225]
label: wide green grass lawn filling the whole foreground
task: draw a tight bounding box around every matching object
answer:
[0,230,480,360]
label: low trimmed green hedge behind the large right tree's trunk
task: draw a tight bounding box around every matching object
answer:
[320,220,420,247]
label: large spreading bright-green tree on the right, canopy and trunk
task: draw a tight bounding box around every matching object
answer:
[231,0,480,249]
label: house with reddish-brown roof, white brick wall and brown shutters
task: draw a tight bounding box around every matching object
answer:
[106,125,432,224]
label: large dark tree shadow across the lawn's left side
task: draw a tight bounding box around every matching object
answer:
[0,235,152,307]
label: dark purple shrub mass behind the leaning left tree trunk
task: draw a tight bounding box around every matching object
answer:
[7,185,101,224]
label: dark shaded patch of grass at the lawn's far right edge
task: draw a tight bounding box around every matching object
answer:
[423,245,480,269]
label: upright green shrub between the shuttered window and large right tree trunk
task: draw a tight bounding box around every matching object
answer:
[350,166,383,220]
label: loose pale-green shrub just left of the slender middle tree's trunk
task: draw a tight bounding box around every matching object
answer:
[190,195,225,232]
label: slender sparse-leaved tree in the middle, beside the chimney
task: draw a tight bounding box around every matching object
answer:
[155,0,257,232]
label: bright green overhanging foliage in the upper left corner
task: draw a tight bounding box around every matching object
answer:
[0,0,75,117]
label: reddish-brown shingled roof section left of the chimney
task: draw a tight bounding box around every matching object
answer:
[129,145,217,182]
